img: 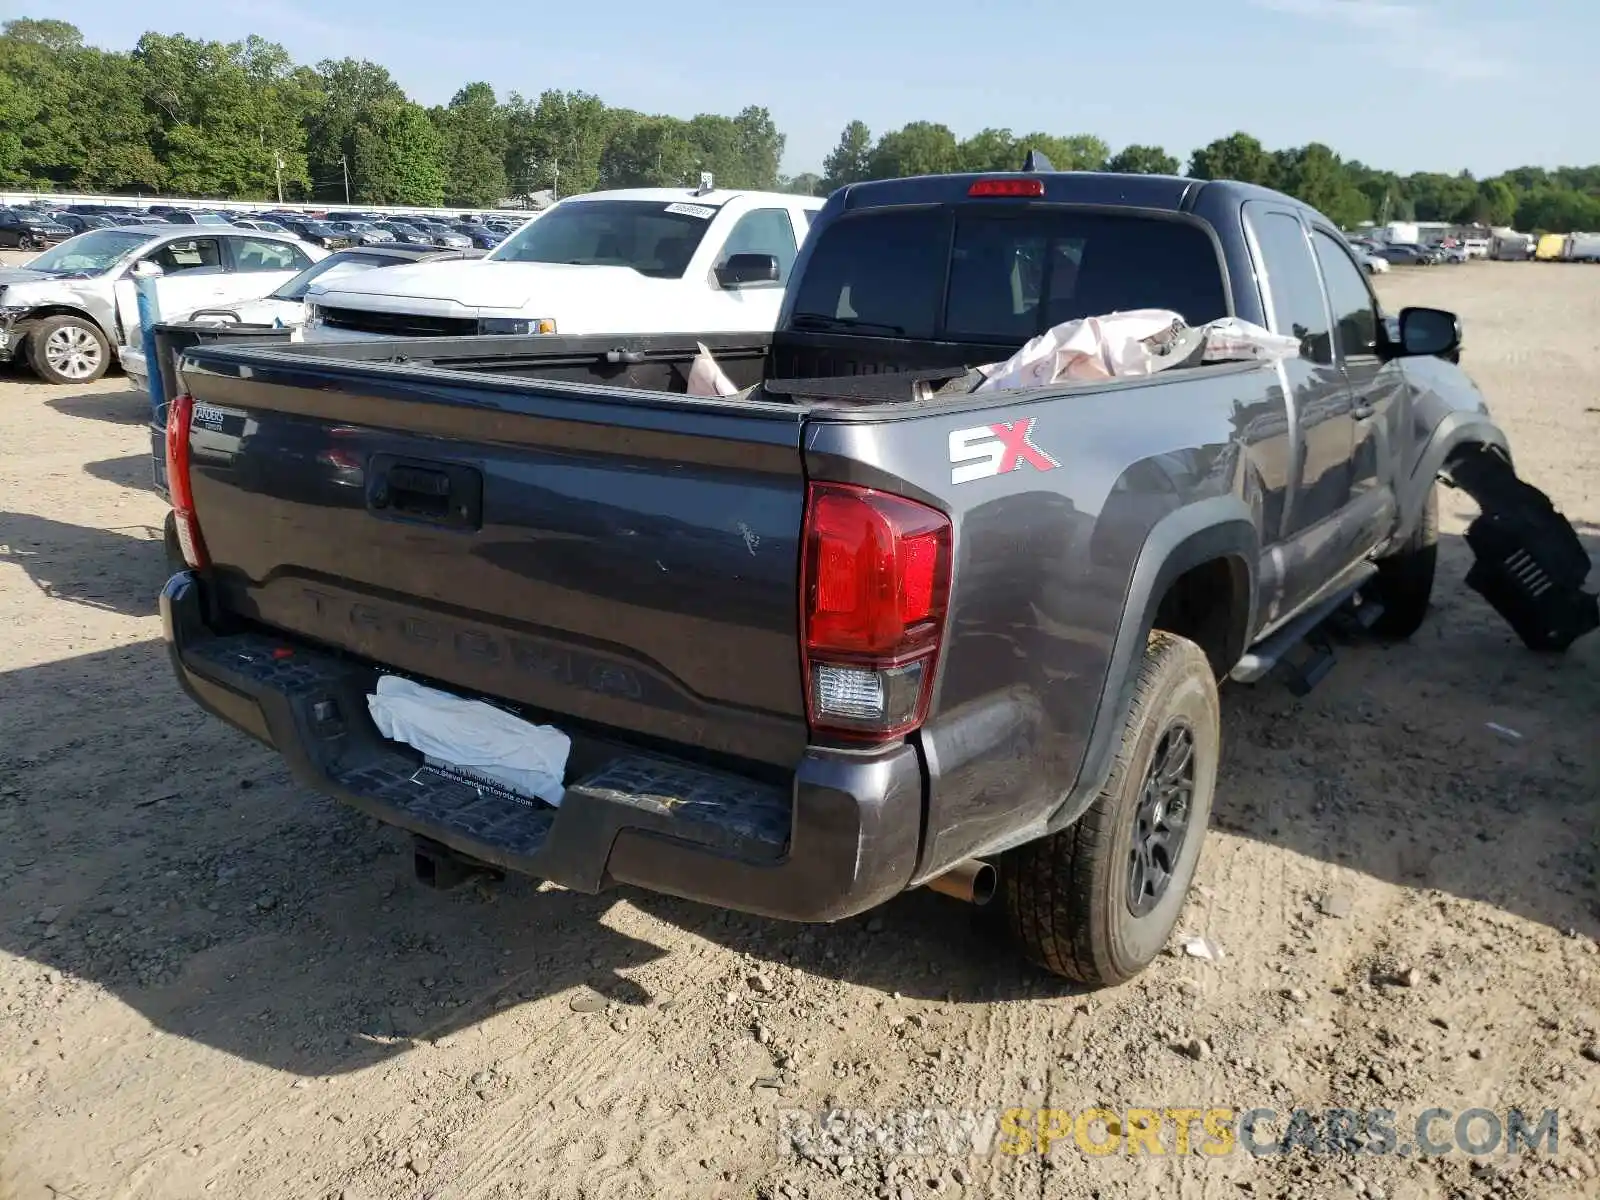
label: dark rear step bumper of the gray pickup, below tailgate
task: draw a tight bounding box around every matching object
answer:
[162,571,922,922]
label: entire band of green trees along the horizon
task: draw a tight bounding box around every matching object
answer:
[0,18,1600,232]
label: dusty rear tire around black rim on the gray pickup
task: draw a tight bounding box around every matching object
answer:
[998,630,1222,987]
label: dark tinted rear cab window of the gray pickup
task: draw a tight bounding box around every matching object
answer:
[794,205,1229,344]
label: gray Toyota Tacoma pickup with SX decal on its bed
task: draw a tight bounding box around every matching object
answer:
[162,171,1595,984]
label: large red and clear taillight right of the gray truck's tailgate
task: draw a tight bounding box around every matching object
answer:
[800,483,950,741]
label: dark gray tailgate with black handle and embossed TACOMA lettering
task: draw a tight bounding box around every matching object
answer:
[184,350,806,768]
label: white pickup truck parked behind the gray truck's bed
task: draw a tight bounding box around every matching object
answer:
[304,187,824,341]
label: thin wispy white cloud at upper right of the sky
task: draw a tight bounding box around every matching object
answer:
[1248,0,1515,83]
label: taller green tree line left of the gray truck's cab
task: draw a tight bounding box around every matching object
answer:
[0,19,784,208]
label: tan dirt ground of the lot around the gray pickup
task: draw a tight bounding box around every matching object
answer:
[0,264,1600,1200]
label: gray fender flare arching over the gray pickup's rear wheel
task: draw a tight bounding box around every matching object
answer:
[1021,494,1261,840]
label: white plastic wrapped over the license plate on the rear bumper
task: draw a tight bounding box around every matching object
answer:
[366,675,573,805]
